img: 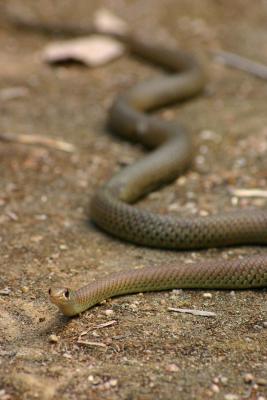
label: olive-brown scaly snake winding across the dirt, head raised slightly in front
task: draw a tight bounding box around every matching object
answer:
[49,33,267,316]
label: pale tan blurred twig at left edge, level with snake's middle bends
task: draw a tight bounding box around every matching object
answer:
[0,132,75,153]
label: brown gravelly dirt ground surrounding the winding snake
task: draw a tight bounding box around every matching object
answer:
[0,0,267,400]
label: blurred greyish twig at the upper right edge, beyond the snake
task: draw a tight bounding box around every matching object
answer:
[213,51,267,80]
